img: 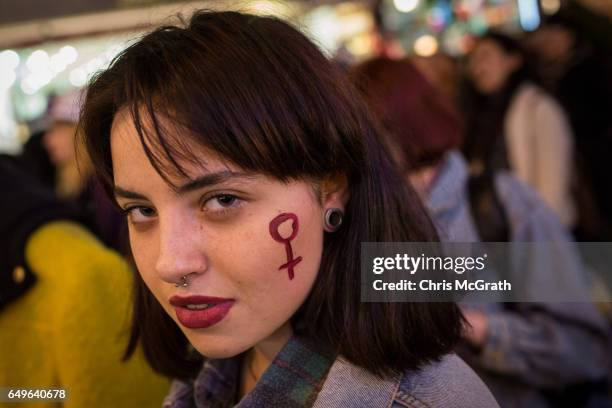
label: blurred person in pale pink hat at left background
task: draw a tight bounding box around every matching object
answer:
[43,90,127,253]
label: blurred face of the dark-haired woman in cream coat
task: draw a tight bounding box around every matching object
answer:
[468,39,522,94]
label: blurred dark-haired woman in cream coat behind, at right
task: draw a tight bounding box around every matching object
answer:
[461,32,576,228]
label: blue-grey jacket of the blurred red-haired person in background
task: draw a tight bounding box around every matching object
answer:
[427,152,610,407]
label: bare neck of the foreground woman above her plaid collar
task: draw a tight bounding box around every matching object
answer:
[240,323,293,399]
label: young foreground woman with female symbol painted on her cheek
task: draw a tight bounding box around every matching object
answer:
[81,12,496,407]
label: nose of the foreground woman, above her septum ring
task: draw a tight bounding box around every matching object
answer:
[155,217,208,283]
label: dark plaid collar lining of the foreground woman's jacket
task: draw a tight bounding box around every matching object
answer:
[190,337,335,408]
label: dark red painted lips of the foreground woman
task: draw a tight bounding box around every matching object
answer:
[170,296,234,329]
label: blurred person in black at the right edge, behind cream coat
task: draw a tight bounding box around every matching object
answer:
[526,11,612,240]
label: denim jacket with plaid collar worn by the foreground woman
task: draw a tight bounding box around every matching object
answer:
[163,337,498,408]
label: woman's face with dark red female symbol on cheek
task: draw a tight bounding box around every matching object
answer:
[111,114,343,358]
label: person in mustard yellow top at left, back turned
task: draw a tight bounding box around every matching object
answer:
[0,156,170,408]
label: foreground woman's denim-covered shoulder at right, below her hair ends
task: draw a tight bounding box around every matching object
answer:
[394,354,498,408]
